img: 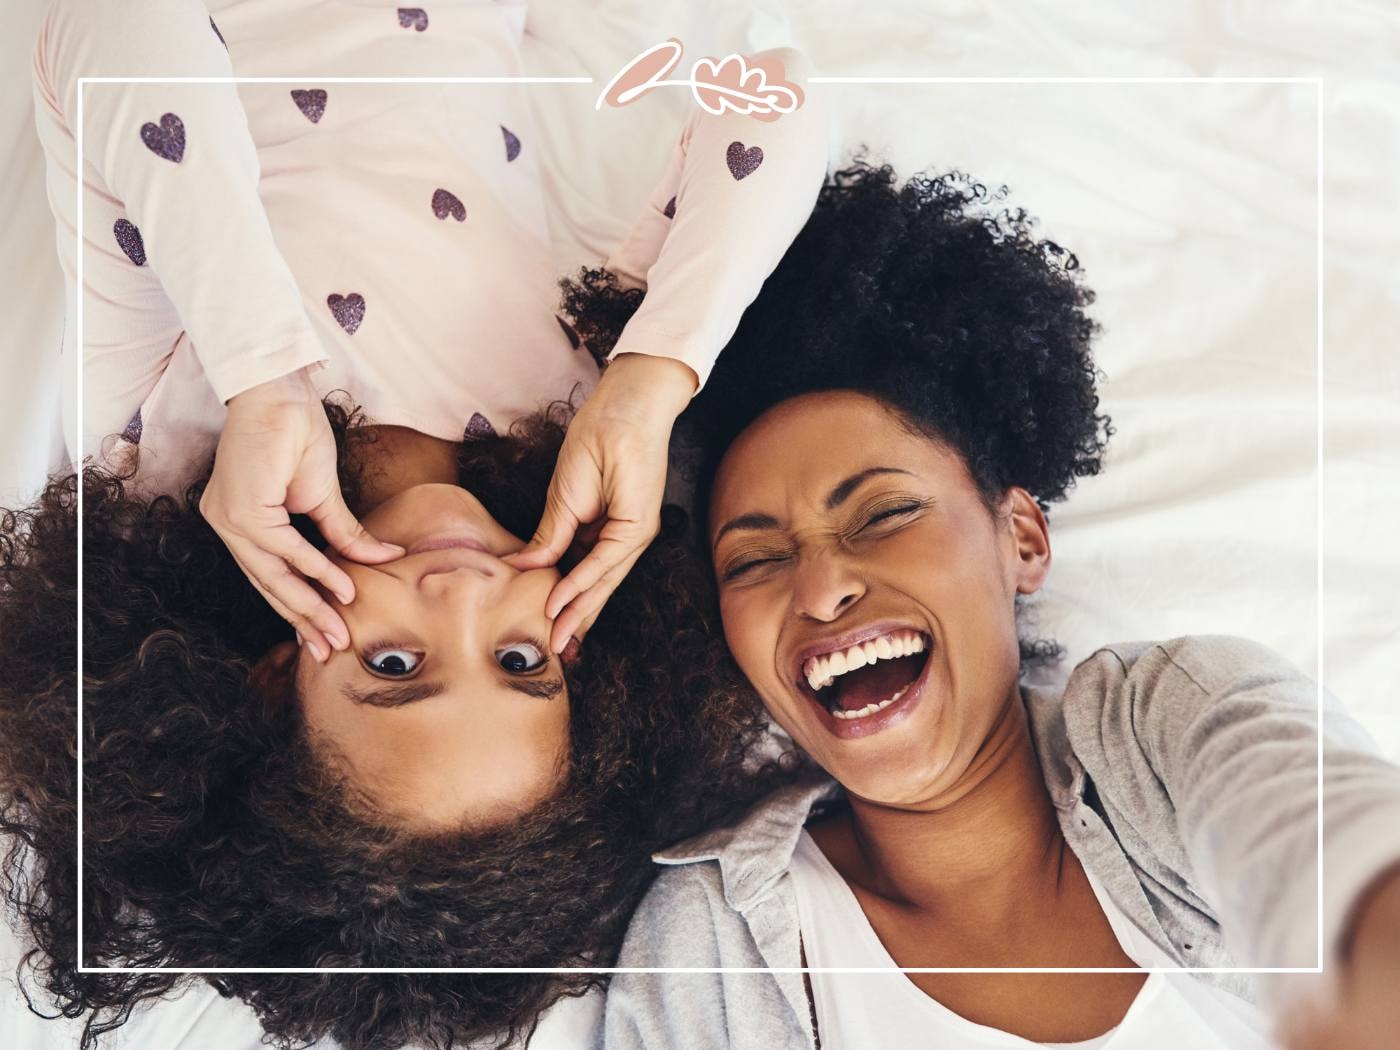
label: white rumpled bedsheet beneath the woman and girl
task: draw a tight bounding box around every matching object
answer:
[0,0,1400,1050]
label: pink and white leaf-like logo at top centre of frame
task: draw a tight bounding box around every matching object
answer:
[594,36,802,120]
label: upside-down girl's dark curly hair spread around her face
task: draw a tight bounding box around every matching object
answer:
[0,402,785,1050]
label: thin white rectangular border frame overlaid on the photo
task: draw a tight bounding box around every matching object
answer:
[76,76,1326,974]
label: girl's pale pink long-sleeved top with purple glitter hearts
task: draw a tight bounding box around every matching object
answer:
[34,0,827,491]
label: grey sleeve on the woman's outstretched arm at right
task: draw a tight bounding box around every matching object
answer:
[1065,636,1400,995]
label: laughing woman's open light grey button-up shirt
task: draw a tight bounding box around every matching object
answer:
[598,637,1400,1050]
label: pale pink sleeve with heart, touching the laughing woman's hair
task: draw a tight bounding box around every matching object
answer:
[605,48,830,389]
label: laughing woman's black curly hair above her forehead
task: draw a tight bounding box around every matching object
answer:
[561,158,1113,666]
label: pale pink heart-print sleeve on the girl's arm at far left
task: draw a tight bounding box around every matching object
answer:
[35,0,326,402]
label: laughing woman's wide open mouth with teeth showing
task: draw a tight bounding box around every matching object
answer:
[798,627,932,739]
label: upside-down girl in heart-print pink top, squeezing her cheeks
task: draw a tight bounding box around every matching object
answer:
[0,0,826,1050]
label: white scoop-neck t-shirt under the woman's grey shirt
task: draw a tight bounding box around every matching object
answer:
[788,832,1274,1050]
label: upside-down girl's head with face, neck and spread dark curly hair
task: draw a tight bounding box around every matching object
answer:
[0,405,776,1049]
